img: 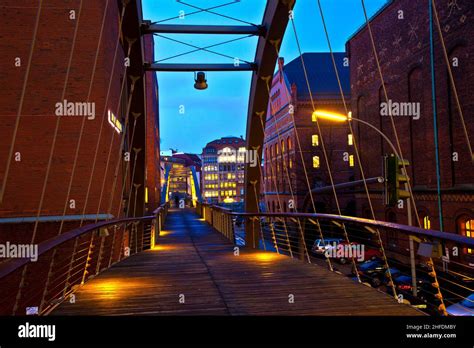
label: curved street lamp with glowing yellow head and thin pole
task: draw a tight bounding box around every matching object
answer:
[312,110,418,296]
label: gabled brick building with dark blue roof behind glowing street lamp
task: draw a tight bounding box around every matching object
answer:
[263,53,354,215]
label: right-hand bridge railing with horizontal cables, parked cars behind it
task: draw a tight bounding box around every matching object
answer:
[196,204,474,315]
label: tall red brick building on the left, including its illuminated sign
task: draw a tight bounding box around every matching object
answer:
[0,0,159,242]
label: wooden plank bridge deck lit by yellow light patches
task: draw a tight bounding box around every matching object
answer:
[52,210,421,315]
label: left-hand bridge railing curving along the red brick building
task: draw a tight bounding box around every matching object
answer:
[0,204,168,315]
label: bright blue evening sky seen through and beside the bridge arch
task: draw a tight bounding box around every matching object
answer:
[143,0,387,153]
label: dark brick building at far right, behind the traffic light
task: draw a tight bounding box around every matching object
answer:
[347,0,474,242]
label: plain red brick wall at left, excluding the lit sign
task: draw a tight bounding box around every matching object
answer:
[0,0,126,245]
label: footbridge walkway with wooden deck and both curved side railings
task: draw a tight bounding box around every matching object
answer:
[0,203,474,316]
